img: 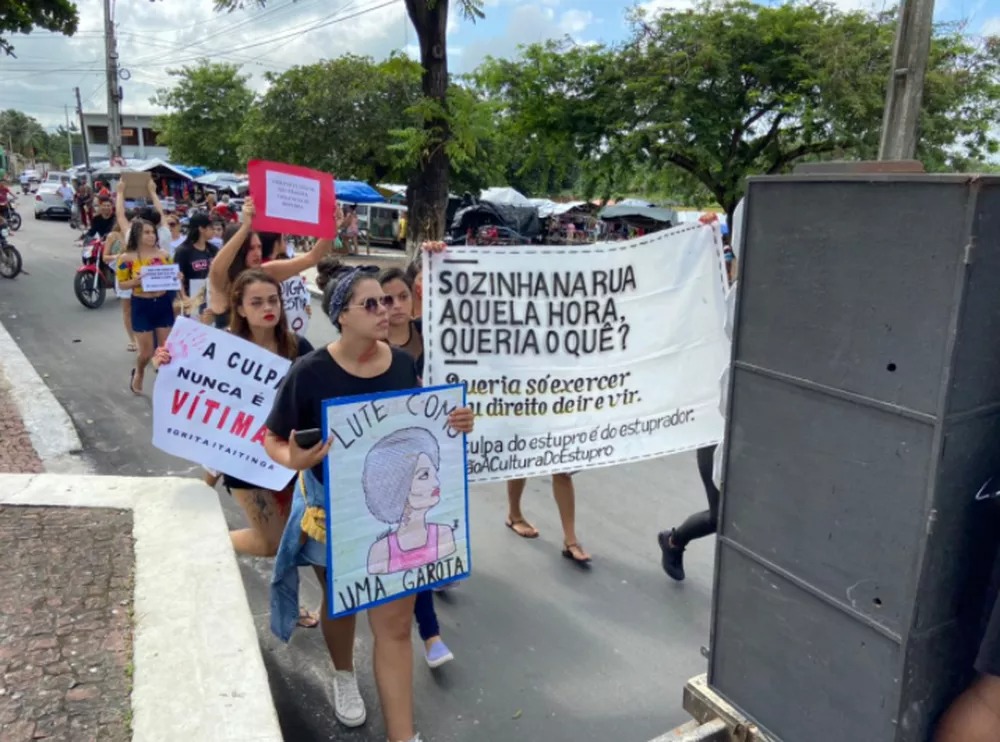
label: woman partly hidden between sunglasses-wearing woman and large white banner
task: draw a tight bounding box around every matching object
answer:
[376,268,455,670]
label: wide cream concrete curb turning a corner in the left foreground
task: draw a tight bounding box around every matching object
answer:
[0,474,282,742]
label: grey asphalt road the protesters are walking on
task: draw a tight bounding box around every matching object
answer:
[0,218,714,742]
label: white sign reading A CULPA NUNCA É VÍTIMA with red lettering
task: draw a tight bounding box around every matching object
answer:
[153,317,295,490]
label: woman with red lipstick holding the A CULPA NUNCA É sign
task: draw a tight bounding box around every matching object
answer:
[154,270,317,576]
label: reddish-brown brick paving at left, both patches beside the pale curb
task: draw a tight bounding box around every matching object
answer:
[0,372,134,742]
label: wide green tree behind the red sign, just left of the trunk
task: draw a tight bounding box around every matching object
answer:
[241,55,420,183]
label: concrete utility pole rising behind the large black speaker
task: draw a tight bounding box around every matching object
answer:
[878,0,934,160]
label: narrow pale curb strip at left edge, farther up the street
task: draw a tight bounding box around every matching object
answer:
[0,324,89,473]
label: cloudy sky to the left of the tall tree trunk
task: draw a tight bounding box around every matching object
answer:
[0,0,415,126]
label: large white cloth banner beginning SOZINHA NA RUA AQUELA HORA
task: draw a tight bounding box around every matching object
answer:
[423,225,729,482]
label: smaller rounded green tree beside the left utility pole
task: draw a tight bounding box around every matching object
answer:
[151,60,254,170]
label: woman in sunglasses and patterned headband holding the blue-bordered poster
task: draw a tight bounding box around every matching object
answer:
[264,264,473,742]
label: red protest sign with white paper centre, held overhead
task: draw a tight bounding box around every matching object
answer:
[247,160,337,239]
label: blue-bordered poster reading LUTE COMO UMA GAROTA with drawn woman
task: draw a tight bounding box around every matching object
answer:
[323,385,471,616]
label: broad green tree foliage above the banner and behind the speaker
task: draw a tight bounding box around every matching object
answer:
[471,0,1000,218]
